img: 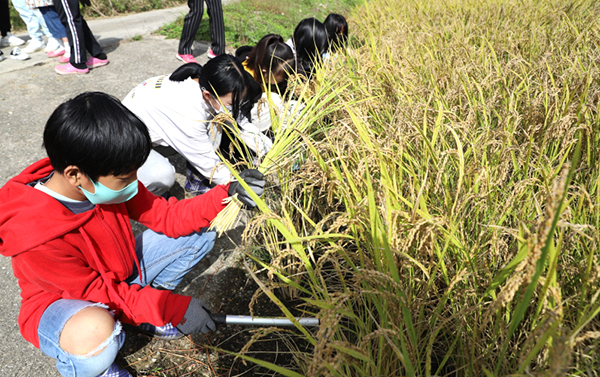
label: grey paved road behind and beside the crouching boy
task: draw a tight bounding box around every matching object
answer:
[0,6,233,377]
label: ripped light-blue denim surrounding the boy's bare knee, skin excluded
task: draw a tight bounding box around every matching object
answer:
[38,299,125,377]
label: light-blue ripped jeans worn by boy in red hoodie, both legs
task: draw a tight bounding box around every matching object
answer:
[38,230,216,377]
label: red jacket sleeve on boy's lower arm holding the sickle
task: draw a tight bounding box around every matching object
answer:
[12,244,191,326]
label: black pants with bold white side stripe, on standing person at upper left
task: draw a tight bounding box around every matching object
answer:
[54,0,106,69]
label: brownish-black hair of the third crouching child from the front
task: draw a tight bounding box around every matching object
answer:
[247,34,294,89]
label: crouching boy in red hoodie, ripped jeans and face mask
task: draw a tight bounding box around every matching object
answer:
[0,92,264,377]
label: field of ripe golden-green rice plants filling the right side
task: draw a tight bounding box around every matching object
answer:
[232,0,600,376]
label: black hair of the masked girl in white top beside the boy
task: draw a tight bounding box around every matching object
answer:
[169,54,254,119]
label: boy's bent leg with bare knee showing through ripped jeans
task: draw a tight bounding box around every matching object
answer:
[38,299,125,377]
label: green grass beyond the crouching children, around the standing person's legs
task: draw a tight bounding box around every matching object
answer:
[159,0,360,48]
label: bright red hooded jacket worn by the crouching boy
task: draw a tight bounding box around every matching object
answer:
[0,158,228,348]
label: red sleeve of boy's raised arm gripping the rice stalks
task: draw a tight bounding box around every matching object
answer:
[125,182,229,238]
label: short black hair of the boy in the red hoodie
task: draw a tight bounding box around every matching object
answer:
[43,92,152,181]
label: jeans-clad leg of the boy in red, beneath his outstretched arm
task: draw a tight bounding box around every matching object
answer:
[127,226,217,290]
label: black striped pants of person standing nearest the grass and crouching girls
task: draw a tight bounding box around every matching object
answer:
[179,0,225,55]
